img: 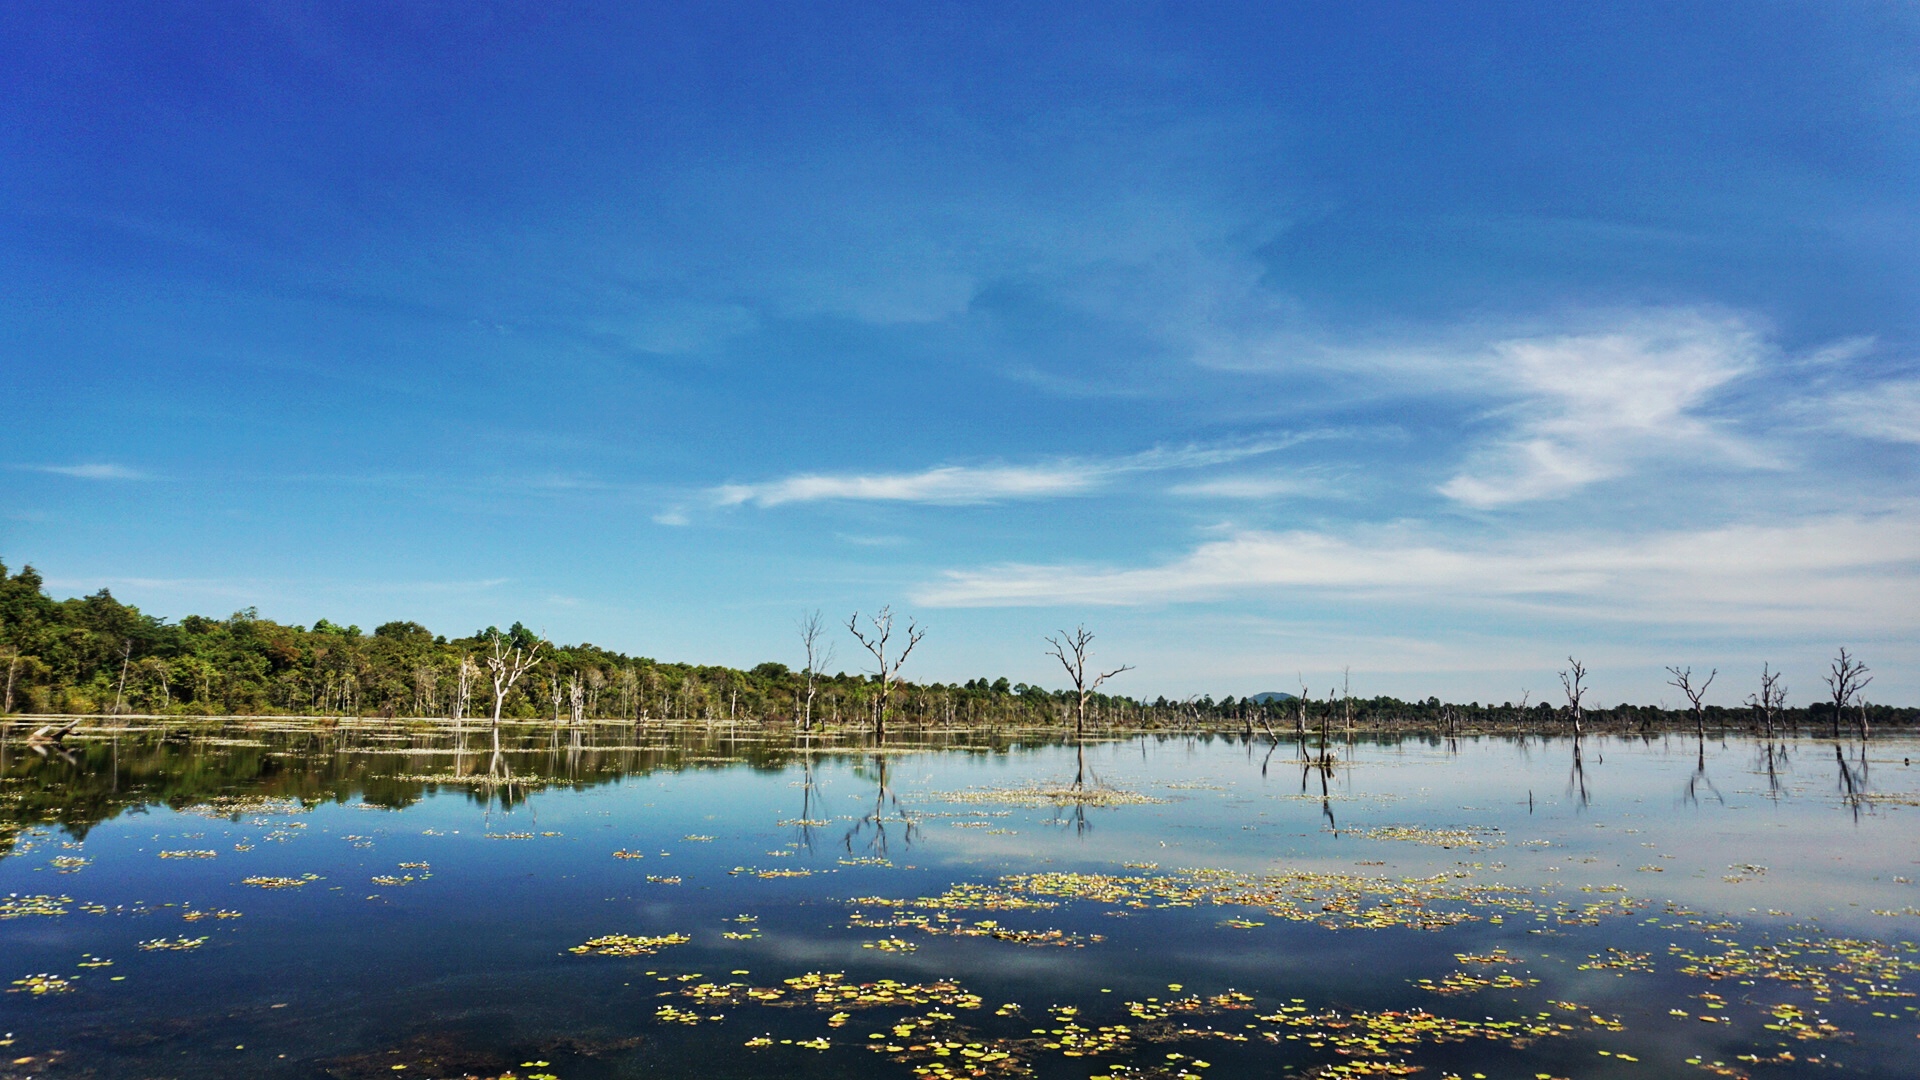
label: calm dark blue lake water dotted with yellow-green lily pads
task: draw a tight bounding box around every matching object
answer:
[0,726,1920,1080]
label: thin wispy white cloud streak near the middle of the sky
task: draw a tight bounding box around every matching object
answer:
[708,436,1302,507]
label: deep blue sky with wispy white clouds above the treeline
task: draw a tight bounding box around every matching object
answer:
[0,0,1920,705]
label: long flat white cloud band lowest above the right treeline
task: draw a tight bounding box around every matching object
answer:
[912,513,1920,630]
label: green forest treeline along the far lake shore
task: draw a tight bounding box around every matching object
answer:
[0,563,1920,732]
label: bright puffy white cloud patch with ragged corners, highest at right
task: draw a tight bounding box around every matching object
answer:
[1440,309,1764,507]
